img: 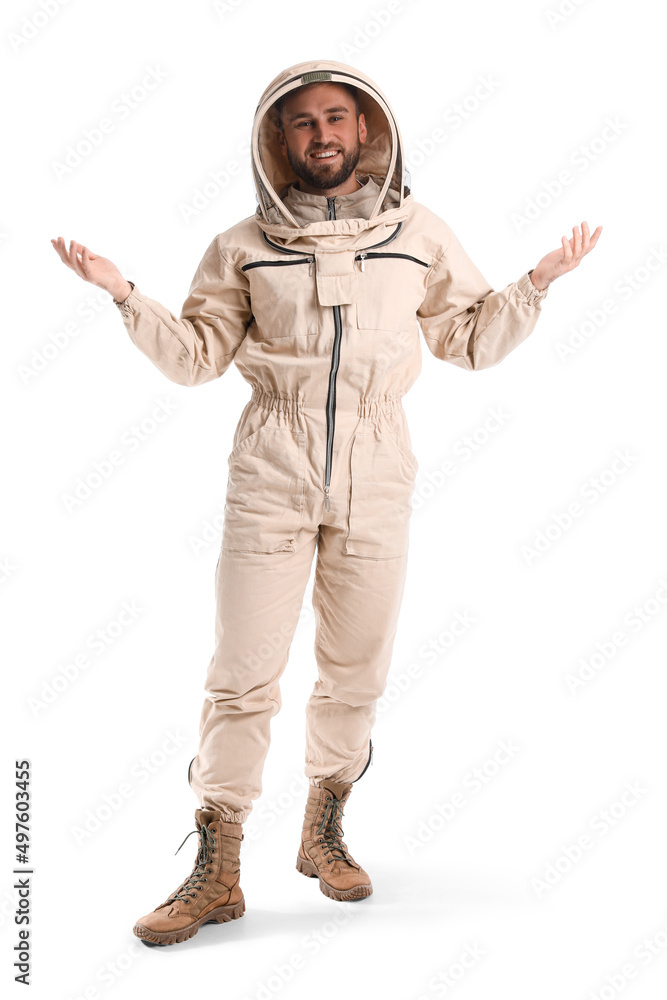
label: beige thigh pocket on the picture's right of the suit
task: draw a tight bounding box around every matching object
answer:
[345,430,417,559]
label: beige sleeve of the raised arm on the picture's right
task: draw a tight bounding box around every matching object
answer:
[417,226,549,370]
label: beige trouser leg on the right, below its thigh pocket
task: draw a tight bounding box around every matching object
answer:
[305,524,408,785]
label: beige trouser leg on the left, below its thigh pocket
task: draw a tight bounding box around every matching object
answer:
[190,530,317,823]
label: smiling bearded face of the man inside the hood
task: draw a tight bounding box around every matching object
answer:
[278,83,367,197]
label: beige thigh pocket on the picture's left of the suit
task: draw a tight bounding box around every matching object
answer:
[222,425,306,552]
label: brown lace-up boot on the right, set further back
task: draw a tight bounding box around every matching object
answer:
[296,779,373,900]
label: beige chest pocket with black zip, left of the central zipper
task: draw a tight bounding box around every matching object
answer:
[241,254,318,340]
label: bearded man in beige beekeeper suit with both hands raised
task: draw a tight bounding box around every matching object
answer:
[54,61,601,944]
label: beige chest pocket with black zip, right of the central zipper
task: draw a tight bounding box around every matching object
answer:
[356,250,431,333]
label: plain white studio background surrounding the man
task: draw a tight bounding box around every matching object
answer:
[0,0,667,1000]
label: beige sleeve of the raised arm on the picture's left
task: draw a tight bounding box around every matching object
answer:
[114,236,252,385]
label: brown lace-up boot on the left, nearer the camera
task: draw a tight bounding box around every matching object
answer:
[133,809,245,945]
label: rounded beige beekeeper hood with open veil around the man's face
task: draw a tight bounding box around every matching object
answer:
[251,60,412,245]
